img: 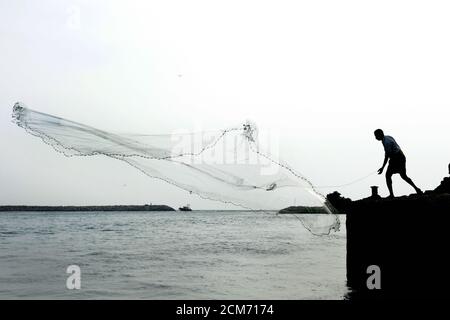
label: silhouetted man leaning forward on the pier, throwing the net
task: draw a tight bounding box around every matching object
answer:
[374,129,423,198]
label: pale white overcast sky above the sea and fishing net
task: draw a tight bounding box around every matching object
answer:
[0,0,450,208]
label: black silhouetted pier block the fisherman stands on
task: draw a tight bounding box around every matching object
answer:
[345,194,450,299]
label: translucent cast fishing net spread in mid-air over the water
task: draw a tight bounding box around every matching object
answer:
[13,103,339,234]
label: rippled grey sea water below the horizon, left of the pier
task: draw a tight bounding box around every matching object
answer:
[0,211,348,299]
